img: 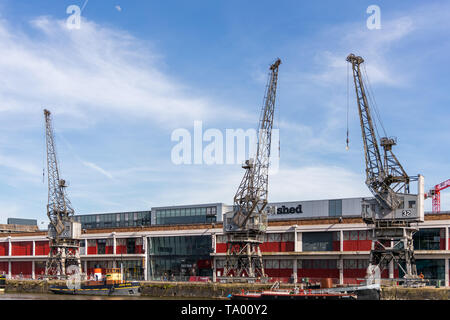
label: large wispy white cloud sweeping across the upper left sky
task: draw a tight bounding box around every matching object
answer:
[0,17,233,125]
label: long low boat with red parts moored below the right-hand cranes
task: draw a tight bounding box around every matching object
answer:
[228,283,381,300]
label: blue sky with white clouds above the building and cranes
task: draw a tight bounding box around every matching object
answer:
[0,0,450,225]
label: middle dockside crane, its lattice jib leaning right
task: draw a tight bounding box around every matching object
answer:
[223,59,281,281]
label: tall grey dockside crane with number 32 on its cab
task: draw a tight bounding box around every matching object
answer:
[347,54,424,280]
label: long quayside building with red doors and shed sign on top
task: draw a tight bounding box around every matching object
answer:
[0,198,450,286]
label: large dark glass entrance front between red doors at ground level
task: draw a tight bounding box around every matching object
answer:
[148,236,212,280]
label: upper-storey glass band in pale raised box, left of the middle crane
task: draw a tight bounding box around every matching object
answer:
[155,207,217,224]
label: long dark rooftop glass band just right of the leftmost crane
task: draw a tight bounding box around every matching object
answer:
[74,211,151,229]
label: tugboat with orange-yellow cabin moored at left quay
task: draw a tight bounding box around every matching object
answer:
[49,268,141,296]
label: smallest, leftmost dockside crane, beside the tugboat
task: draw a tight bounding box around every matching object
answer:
[44,110,81,279]
